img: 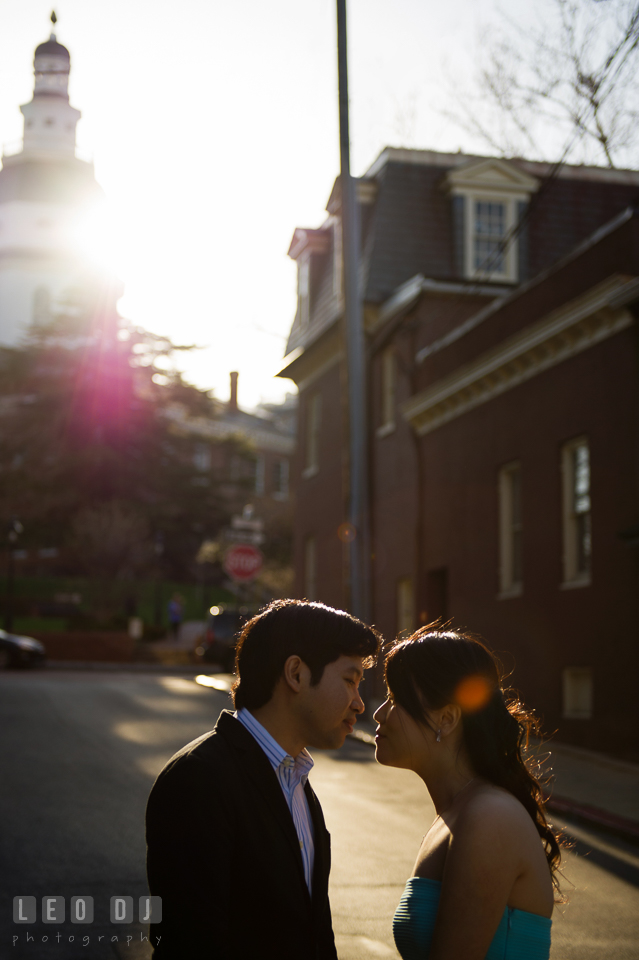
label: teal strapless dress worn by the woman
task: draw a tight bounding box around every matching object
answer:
[393,877,552,960]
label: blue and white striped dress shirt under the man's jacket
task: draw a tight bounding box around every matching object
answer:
[235,707,315,894]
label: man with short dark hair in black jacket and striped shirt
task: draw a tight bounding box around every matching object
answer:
[147,600,380,960]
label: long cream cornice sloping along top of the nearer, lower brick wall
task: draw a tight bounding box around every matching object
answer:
[401,276,639,436]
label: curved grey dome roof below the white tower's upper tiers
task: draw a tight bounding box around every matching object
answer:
[0,159,102,204]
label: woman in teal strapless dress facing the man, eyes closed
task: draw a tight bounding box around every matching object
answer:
[375,627,560,960]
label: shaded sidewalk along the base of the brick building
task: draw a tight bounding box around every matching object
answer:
[352,720,639,843]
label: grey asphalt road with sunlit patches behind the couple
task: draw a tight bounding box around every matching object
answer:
[0,671,639,960]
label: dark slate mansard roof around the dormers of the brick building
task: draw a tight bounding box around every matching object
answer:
[286,149,639,354]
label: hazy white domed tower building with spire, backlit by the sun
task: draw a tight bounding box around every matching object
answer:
[0,22,116,346]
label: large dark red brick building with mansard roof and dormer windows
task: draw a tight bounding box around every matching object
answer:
[280,149,639,758]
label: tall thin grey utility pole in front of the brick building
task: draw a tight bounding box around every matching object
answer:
[337,0,370,621]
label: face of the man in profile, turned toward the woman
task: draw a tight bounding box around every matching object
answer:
[297,656,364,750]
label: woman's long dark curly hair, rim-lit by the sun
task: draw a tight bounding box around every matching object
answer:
[385,625,561,898]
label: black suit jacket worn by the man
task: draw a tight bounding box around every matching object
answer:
[146,711,337,960]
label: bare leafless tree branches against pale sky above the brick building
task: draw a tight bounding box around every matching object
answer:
[444,0,639,167]
